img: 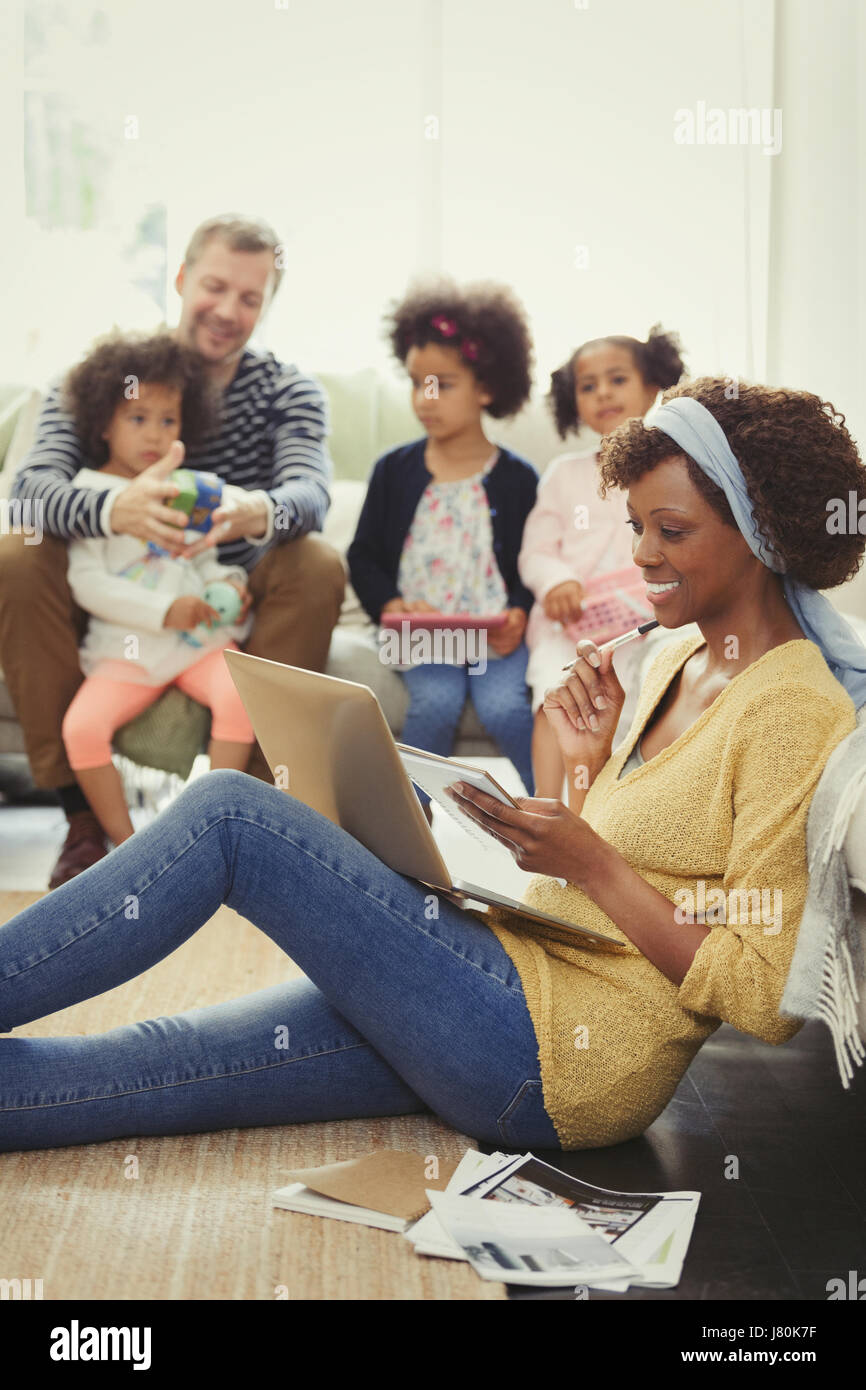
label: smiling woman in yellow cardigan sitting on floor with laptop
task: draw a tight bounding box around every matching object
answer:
[0,379,866,1151]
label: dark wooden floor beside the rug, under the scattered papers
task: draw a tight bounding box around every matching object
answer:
[484,1023,866,1301]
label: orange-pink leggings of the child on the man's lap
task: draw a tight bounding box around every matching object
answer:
[63,642,256,770]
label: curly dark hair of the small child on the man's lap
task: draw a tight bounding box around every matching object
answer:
[63,332,217,466]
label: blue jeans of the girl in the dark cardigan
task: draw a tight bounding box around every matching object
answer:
[400,642,535,802]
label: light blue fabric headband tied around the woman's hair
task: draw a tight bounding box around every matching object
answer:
[644,396,866,709]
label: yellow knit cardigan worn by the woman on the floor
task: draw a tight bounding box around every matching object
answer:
[482,634,856,1150]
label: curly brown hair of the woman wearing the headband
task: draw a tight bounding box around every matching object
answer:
[599,377,866,589]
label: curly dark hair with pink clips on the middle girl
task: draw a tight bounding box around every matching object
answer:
[385,278,532,420]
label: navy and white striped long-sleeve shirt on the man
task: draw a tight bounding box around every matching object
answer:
[13,349,334,570]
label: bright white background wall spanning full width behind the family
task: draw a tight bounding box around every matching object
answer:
[0,0,866,608]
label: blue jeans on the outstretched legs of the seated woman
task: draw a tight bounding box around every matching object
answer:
[0,771,559,1151]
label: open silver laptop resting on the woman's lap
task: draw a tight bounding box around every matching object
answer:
[225,652,621,945]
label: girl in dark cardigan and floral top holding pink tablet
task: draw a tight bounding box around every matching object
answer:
[348,281,538,806]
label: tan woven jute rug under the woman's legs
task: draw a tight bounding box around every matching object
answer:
[0,892,506,1300]
